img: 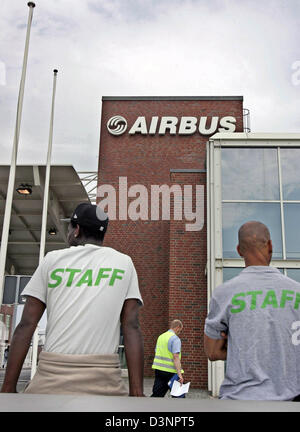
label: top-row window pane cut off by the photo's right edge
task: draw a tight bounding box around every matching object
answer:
[280,149,300,200]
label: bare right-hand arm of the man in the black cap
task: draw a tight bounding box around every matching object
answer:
[121,299,144,396]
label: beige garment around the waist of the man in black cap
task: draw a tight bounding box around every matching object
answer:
[24,351,128,396]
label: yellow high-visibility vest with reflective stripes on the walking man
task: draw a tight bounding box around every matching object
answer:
[152,330,184,373]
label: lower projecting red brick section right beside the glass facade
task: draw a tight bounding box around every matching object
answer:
[169,173,207,388]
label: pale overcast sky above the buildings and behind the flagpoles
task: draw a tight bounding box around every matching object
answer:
[0,0,300,170]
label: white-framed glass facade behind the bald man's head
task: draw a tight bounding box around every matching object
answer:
[221,146,300,281]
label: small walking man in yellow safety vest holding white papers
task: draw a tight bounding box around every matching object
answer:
[151,319,183,397]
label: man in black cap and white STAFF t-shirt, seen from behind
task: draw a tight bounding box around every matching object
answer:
[1,203,144,396]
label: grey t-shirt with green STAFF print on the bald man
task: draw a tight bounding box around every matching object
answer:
[204,266,300,400]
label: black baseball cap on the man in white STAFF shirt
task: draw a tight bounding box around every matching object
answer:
[63,203,109,233]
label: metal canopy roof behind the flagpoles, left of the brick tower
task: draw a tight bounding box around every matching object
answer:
[0,165,90,275]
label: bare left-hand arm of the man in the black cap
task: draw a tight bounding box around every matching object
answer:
[1,296,46,393]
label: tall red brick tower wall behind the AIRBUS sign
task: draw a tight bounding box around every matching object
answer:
[98,98,243,388]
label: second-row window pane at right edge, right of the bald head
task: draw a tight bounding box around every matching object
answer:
[284,204,300,258]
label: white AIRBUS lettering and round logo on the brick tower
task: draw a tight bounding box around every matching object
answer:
[107,115,236,135]
